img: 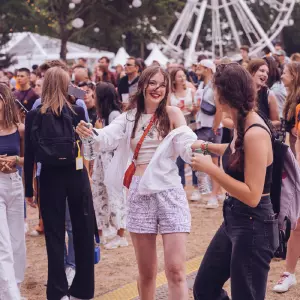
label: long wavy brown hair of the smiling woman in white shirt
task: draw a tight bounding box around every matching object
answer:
[127,66,171,138]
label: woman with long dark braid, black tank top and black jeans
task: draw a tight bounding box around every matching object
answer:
[192,63,279,300]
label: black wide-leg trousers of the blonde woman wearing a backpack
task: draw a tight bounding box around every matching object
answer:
[40,165,95,300]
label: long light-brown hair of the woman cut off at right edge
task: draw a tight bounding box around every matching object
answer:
[283,62,300,121]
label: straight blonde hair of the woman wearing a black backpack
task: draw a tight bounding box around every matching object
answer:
[41,67,72,116]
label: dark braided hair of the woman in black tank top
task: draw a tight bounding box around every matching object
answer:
[213,63,256,171]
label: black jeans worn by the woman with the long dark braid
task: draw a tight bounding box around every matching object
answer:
[194,196,279,300]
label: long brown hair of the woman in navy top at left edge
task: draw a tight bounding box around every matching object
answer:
[0,83,20,129]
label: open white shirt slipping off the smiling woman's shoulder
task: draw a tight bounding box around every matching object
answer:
[94,110,197,195]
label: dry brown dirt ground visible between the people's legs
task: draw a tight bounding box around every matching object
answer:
[22,189,300,300]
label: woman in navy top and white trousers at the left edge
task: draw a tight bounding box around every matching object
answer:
[0,84,26,300]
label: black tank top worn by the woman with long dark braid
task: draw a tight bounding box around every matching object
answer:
[222,124,273,194]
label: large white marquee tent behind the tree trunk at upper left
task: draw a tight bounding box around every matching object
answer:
[1,32,115,68]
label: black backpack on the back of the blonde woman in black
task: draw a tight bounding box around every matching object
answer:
[31,107,76,167]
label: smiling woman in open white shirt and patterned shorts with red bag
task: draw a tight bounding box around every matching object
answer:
[76,66,197,300]
